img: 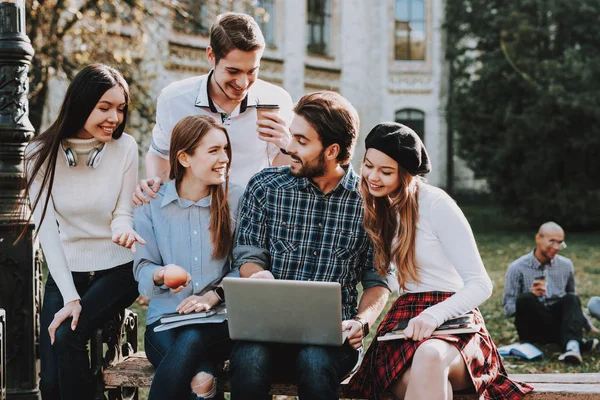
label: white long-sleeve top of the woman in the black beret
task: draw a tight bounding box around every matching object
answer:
[405,182,492,325]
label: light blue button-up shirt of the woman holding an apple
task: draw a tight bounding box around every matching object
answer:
[133,181,244,325]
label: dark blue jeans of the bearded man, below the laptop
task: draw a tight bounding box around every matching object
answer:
[230,342,358,400]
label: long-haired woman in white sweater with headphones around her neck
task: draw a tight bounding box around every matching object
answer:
[20,64,143,400]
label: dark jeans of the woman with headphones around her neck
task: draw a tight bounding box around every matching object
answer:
[40,262,138,400]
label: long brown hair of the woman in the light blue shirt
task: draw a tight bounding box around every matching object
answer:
[169,115,233,260]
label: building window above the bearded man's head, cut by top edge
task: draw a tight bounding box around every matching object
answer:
[306,0,331,55]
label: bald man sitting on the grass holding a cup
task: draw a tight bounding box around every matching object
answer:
[503,222,598,364]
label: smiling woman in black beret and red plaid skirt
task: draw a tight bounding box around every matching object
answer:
[351,123,532,399]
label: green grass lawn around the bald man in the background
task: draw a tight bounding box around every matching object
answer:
[123,205,600,398]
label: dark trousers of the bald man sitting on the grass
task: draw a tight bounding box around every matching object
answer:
[515,292,585,349]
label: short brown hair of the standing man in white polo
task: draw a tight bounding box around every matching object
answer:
[210,12,265,63]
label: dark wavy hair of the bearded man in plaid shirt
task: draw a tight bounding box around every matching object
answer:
[294,90,360,165]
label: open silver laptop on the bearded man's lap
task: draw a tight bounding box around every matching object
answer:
[223,278,346,346]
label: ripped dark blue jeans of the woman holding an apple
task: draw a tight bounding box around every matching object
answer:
[144,321,231,400]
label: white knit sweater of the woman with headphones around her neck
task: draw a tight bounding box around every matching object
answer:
[25,133,138,304]
